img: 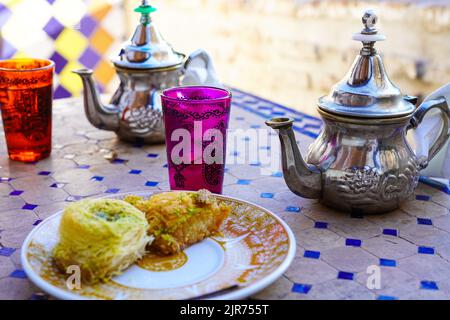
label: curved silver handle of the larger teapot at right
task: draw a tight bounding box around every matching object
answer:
[408,95,450,169]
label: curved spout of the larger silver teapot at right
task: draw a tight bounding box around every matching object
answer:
[266,118,322,199]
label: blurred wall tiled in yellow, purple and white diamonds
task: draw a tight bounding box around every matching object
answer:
[0,0,126,98]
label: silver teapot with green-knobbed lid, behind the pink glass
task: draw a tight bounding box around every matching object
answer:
[73,0,221,144]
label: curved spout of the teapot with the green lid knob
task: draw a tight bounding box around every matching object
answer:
[73,69,119,131]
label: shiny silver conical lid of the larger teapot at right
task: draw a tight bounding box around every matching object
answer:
[318,10,415,118]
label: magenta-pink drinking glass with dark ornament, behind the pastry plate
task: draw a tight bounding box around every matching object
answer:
[161,86,231,194]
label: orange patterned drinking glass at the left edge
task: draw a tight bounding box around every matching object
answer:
[0,59,54,162]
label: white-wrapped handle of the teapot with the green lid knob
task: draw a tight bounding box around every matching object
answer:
[182,49,224,88]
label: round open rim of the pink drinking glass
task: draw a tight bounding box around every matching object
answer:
[161,86,232,104]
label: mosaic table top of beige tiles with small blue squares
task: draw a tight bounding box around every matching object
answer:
[0,90,450,299]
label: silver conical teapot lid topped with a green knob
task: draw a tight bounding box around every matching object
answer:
[113,0,185,69]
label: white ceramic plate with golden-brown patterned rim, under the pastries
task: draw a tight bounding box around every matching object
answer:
[21,192,296,299]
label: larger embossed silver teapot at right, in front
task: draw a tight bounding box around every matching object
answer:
[266,10,450,214]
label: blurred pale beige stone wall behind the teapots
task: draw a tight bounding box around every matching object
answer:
[125,0,450,114]
